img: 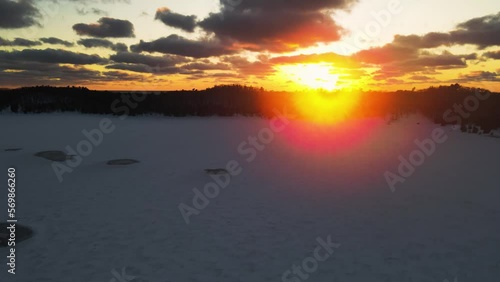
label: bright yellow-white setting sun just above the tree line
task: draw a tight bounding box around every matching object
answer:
[280,63,339,91]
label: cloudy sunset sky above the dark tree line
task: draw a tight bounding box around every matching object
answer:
[0,0,500,91]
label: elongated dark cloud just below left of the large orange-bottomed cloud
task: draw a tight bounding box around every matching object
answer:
[130,34,235,58]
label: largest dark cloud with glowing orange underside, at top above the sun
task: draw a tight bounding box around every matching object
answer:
[199,0,356,52]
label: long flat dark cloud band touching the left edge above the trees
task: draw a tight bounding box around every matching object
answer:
[0,49,107,65]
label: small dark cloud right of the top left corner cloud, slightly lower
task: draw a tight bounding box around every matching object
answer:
[73,17,135,38]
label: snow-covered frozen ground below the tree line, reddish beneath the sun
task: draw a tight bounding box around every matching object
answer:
[0,114,500,282]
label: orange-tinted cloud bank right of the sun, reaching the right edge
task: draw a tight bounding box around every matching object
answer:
[352,13,500,80]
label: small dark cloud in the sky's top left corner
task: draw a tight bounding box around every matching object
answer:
[0,0,40,29]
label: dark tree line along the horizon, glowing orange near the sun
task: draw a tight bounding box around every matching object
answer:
[0,84,500,132]
